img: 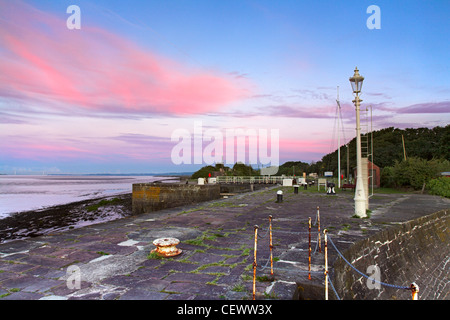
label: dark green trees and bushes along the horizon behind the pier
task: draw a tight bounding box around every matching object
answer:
[192,125,450,195]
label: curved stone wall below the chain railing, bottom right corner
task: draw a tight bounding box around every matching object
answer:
[330,210,450,300]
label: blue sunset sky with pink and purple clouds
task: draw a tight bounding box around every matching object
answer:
[0,0,450,174]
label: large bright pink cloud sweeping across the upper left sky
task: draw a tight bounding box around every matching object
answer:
[0,0,249,114]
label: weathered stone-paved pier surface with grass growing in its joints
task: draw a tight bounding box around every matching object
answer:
[0,187,450,300]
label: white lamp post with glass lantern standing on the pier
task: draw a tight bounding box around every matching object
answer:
[349,68,367,218]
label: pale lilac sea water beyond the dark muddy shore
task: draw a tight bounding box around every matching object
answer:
[0,175,177,219]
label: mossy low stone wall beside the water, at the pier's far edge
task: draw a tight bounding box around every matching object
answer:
[132,183,220,214]
